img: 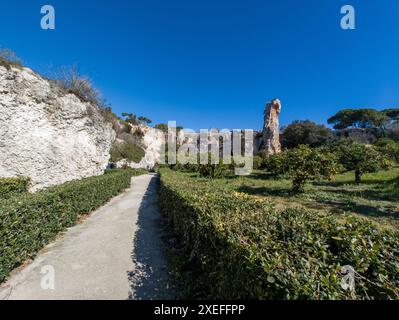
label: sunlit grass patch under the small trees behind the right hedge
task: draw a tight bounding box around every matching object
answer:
[209,167,399,228]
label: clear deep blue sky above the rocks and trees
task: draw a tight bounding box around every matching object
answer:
[0,0,399,129]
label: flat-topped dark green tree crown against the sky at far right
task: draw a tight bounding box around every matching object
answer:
[328,109,388,129]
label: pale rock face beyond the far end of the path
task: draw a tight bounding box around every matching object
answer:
[116,125,165,169]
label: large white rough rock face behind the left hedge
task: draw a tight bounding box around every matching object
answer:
[0,66,115,191]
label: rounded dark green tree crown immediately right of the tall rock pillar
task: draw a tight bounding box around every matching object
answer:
[281,120,333,148]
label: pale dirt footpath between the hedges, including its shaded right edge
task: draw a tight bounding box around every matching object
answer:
[0,175,174,300]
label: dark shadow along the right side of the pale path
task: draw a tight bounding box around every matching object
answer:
[127,175,175,300]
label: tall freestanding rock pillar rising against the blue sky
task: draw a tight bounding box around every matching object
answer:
[262,99,281,155]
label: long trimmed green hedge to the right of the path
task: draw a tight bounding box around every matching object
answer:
[160,169,399,299]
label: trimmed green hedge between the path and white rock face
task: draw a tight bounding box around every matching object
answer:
[0,170,141,282]
